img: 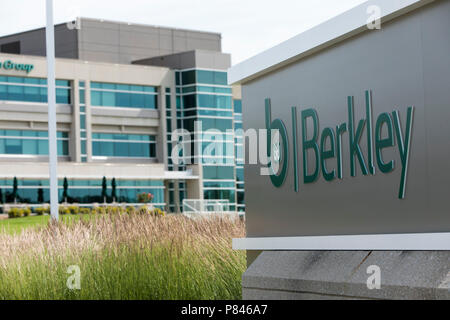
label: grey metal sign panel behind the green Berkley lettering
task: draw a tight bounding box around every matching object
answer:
[232,1,450,250]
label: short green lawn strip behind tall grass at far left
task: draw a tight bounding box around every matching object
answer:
[0,215,82,234]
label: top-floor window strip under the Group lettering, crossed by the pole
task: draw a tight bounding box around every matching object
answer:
[0,76,70,104]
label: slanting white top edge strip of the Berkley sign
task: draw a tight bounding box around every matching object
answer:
[228,0,435,84]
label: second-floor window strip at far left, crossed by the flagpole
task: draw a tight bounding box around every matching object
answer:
[0,130,69,156]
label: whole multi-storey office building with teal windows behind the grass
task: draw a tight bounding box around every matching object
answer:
[0,19,245,212]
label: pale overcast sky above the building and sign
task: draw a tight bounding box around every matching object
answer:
[0,0,366,64]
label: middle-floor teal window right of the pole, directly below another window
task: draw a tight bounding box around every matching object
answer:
[92,133,156,158]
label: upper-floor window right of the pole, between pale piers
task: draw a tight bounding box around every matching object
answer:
[91,82,158,109]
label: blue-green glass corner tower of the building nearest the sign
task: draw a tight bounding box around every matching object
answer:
[176,69,236,210]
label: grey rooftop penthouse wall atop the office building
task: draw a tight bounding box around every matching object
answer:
[0,18,222,64]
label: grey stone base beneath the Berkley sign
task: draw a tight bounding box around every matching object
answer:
[242,251,450,300]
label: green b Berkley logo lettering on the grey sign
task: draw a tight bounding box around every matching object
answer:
[265,91,414,199]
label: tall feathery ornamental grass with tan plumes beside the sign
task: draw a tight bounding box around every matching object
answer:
[0,214,245,299]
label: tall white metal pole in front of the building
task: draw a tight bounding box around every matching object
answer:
[45,0,58,221]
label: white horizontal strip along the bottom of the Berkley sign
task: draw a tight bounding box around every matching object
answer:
[233,232,450,250]
